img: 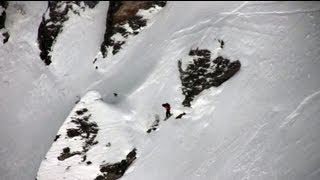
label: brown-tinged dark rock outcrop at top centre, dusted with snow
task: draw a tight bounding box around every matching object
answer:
[99,1,167,59]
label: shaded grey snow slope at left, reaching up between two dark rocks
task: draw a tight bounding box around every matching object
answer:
[0,2,108,180]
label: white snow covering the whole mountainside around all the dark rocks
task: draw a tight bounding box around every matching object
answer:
[0,1,320,180]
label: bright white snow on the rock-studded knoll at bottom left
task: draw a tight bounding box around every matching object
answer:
[37,92,133,180]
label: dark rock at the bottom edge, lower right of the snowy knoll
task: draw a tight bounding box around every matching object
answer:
[95,148,137,180]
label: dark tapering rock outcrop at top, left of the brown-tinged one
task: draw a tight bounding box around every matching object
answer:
[38,1,99,65]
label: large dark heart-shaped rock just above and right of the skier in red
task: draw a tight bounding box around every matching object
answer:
[178,47,241,107]
